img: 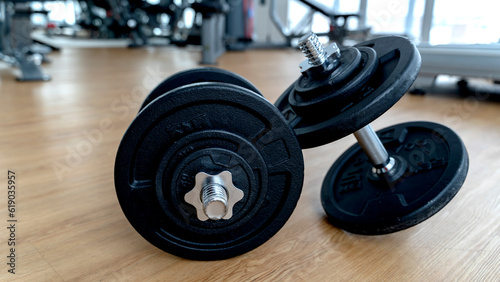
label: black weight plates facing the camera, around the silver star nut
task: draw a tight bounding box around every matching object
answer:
[115,82,304,260]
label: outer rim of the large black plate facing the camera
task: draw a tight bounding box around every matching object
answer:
[114,82,304,260]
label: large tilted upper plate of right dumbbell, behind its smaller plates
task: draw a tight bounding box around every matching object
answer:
[275,36,421,149]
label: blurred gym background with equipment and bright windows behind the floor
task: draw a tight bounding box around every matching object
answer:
[0,0,500,94]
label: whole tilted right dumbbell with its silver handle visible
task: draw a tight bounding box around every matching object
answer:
[275,33,468,235]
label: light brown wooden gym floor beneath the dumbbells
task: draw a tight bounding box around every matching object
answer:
[0,45,500,281]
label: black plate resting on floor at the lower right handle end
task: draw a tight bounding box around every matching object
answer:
[321,122,469,235]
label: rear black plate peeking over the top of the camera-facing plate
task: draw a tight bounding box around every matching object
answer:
[139,67,262,112]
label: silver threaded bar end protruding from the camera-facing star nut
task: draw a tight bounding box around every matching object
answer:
[201,183,227,220]
